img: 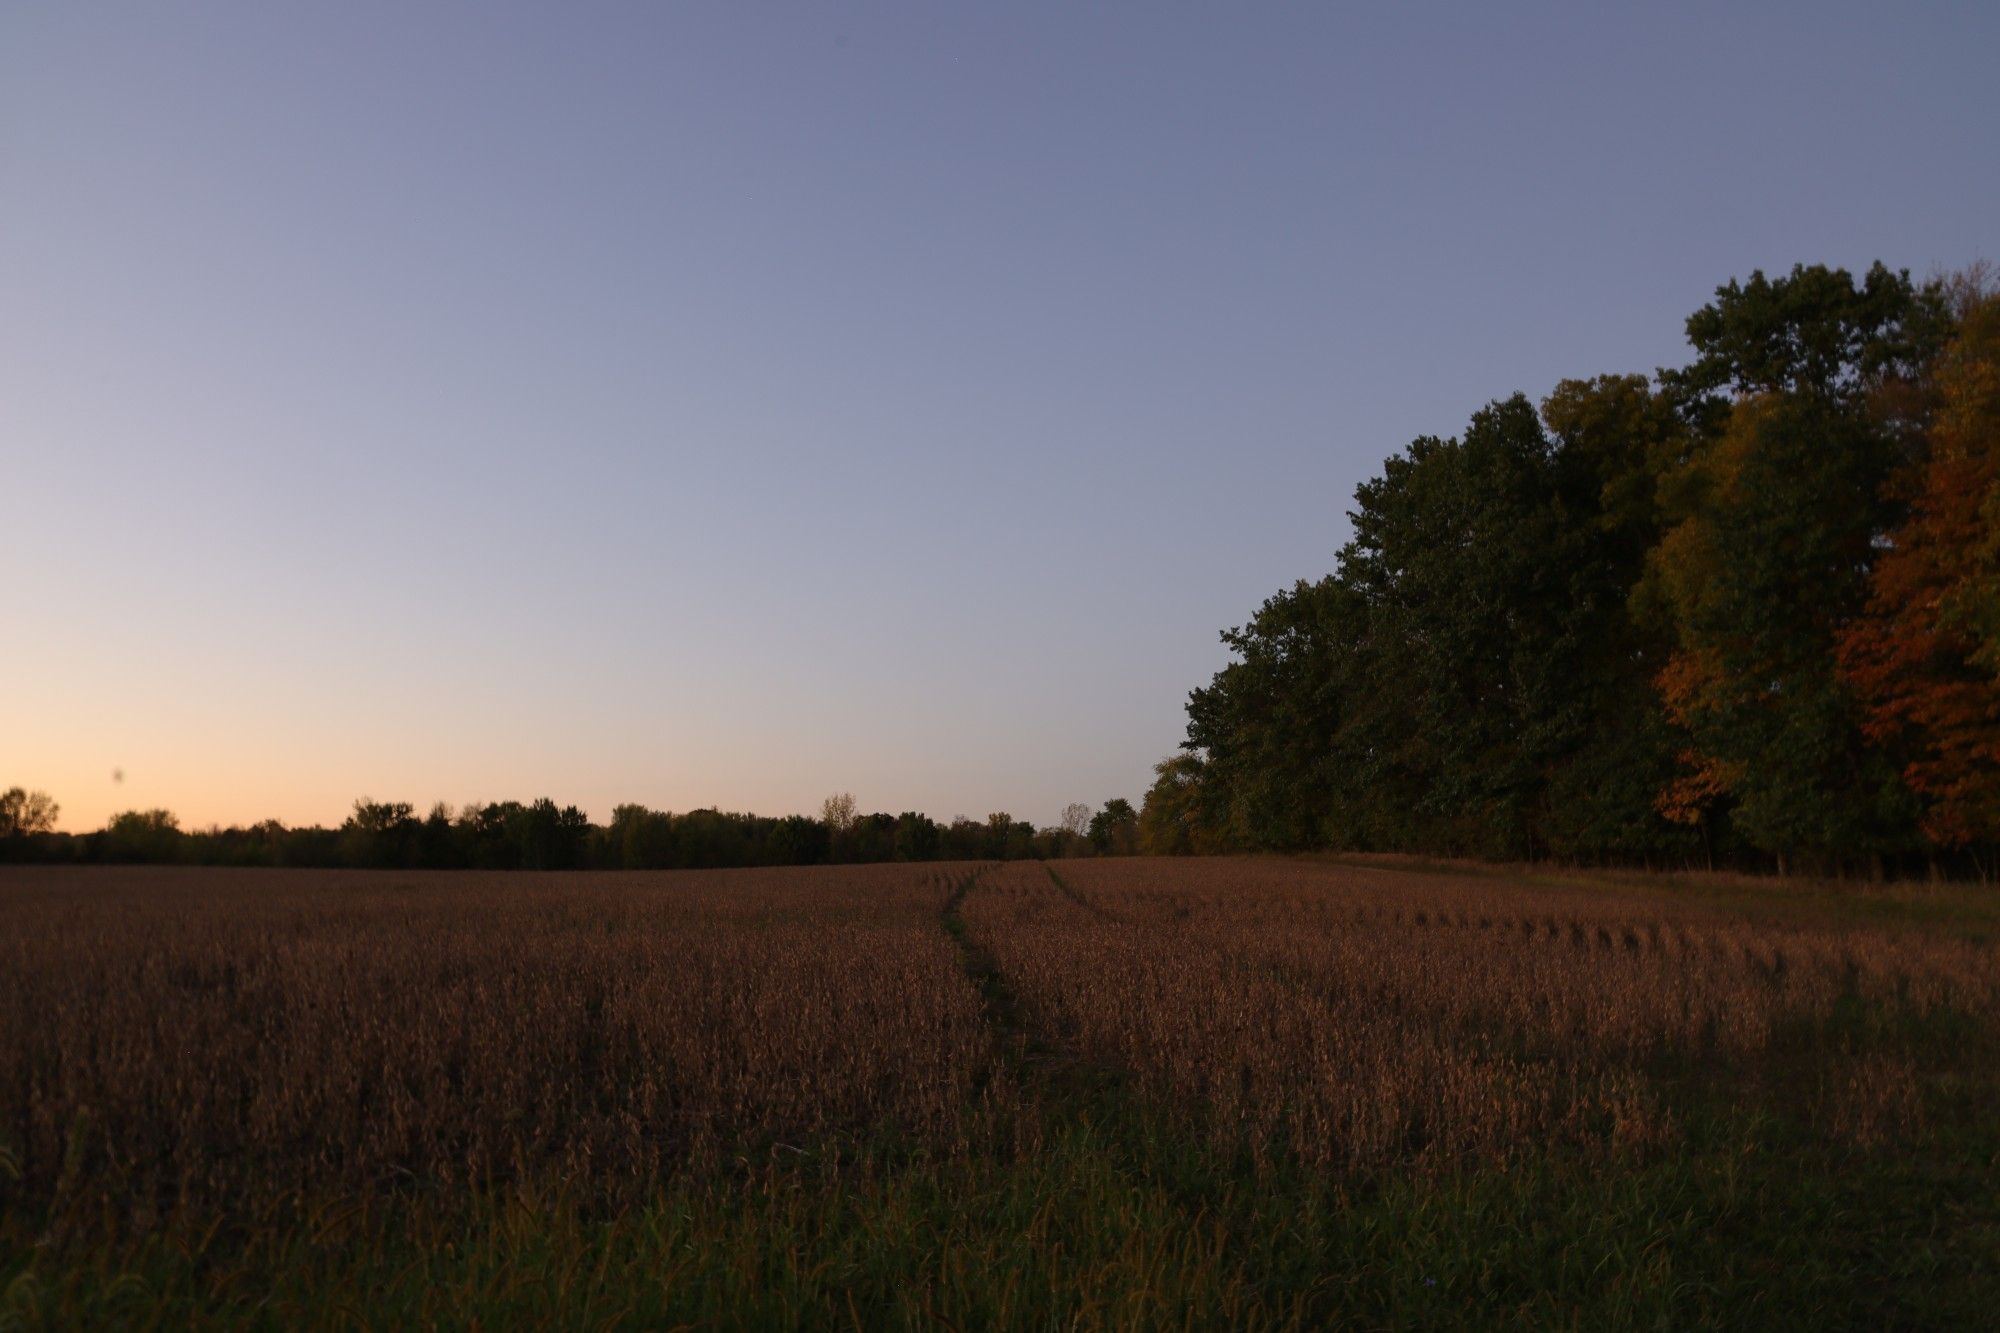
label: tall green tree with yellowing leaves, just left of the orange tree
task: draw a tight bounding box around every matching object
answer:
[1644,264,1944,865]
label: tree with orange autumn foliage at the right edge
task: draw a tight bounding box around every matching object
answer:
[1840,282,2000,847]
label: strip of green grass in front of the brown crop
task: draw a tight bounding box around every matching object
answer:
[0,1093,2000,1329]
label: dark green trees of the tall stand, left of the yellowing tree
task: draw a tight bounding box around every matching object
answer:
[1188,380,1682,859]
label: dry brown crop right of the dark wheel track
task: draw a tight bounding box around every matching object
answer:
[966,861,2000,1169]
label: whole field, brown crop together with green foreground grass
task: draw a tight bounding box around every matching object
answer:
[0,859,2000,1329]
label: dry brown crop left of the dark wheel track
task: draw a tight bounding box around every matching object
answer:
[0,867,990,1221]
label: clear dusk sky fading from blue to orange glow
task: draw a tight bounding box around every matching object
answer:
[0,0,2000,831]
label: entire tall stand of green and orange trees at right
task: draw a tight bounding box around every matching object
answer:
[1142,264,2000,879]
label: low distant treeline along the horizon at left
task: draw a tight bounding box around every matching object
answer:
[0,789,1138,871]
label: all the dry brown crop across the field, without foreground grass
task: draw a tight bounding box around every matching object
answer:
[0,861,2000,1225]
